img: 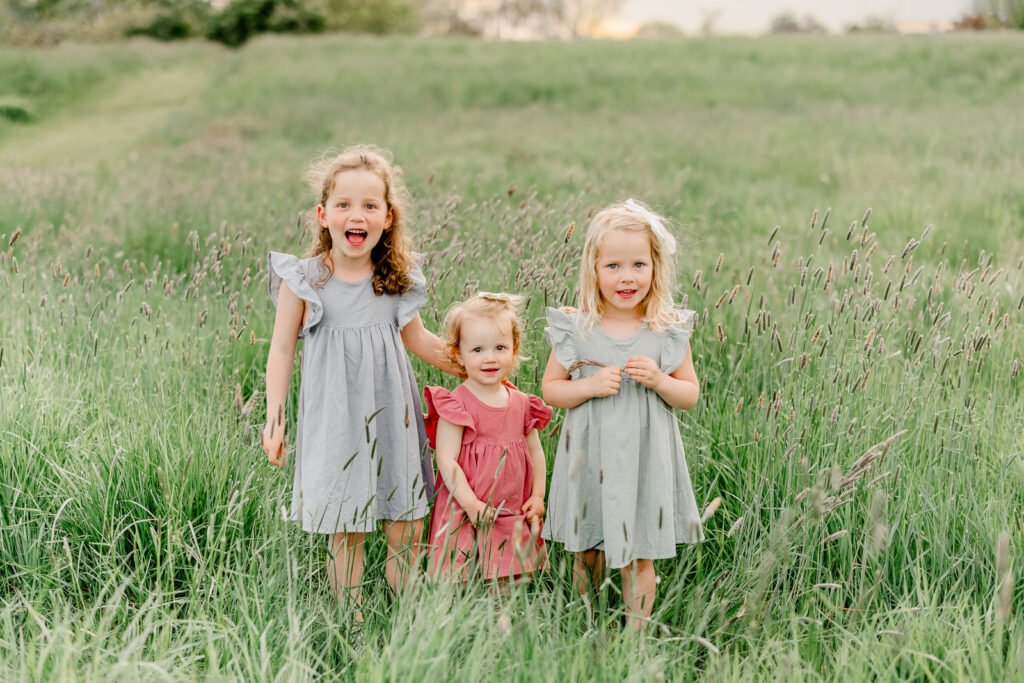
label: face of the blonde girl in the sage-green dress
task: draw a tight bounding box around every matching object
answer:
[597,230,654,315]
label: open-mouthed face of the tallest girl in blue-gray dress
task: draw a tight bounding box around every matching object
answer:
[316,169,392,265]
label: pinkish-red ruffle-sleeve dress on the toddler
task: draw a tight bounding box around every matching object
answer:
[423,384,551,581]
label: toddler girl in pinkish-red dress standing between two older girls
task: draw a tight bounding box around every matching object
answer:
[423,293,551,581]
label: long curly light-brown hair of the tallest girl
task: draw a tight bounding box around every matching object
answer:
[302,144,413,296]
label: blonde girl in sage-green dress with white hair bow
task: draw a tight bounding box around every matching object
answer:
[542,200,703,629]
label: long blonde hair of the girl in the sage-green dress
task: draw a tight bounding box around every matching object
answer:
[578,203,679,332]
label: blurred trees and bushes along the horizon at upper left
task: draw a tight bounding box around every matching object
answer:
[0,0,623,47]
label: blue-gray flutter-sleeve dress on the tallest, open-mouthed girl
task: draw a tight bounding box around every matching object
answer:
[268,252,434,533]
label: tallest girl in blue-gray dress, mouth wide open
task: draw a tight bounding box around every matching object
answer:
[263,146,458,620]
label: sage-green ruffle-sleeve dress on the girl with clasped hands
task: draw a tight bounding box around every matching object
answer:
[542,308,703,568]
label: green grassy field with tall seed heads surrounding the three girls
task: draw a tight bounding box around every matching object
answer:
[0,34,1024,681]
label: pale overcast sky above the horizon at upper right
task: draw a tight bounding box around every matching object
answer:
[618,0,976,33]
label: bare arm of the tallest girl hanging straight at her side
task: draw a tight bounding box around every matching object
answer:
[263,283,306,466]
